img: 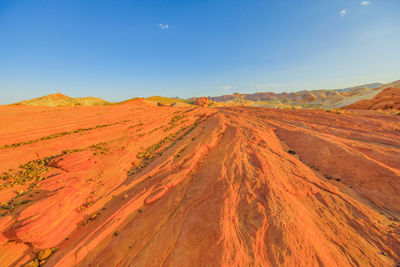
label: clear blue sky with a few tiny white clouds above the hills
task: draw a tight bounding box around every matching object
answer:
[0,0,400,104]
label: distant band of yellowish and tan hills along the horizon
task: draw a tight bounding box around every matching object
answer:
[7,82,399,109]
